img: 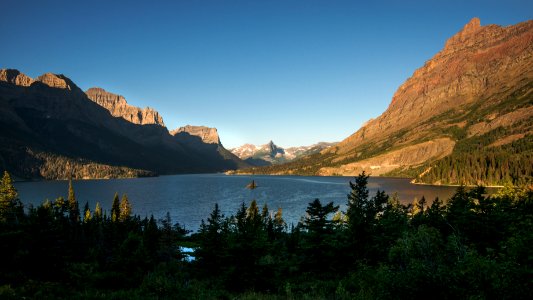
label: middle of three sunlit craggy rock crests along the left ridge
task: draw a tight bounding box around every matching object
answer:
[85,88,165,126]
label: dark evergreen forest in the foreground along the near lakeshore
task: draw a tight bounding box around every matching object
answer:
[0,172,533,299]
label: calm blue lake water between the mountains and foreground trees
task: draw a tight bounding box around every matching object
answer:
[15,174,456,230]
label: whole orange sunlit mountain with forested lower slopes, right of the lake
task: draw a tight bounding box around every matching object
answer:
[249,18,533,184]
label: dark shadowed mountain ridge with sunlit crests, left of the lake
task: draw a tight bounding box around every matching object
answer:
[0,70,248,179]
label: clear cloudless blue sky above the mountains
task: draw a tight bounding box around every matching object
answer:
[0,0,533,148]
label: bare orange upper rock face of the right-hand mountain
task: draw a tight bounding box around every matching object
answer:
[336,18,533,154]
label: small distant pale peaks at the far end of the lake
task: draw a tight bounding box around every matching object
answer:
[230,141,336,166]
